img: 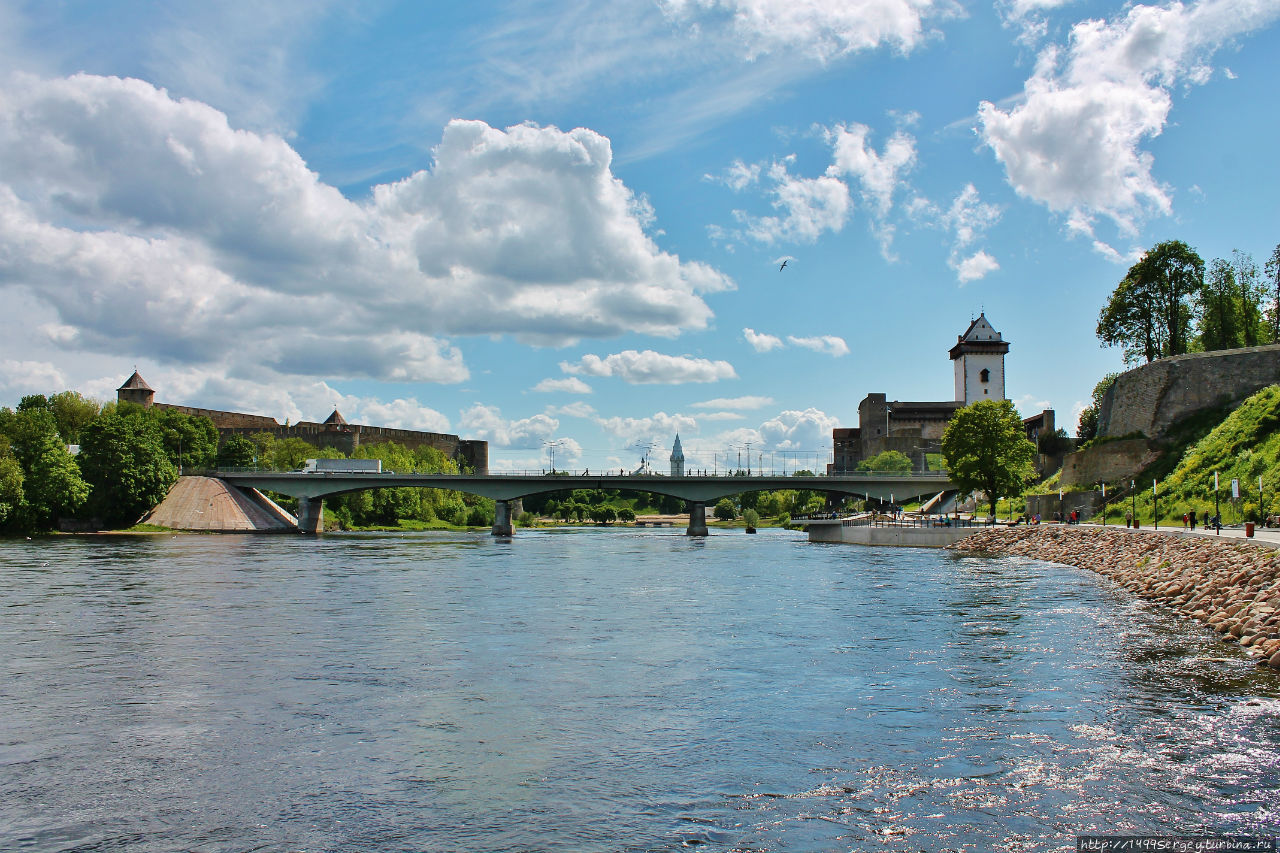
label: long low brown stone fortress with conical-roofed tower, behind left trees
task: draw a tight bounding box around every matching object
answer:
[115,370,489,474]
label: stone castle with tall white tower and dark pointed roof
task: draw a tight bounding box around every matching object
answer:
[827,313,1055,474]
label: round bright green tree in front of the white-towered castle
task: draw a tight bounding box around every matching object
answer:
[942,400,1036,516]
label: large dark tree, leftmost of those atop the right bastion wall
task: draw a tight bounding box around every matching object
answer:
[1097,240,1204,362]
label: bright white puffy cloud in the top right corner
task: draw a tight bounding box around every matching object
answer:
[978,0,1280,242]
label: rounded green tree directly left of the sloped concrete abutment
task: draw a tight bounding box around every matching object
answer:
[76,410,178,525]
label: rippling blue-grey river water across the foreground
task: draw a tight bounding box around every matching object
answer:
[0,529,1280,852]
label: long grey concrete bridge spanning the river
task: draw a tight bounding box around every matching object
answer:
[218,471,956,537]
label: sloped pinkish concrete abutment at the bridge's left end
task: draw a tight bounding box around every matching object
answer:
[143,476,298,533]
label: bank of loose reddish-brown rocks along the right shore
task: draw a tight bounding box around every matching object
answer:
[948,525,1280,669]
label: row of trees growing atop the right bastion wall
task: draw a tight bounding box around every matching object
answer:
[1097,240,1280,364]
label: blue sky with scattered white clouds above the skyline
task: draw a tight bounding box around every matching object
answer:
[0,0,1280,471]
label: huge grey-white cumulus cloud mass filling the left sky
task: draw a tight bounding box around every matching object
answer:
[0,74,732,391]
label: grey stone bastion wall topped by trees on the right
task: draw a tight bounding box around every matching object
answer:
[1098,345,1280,439]
